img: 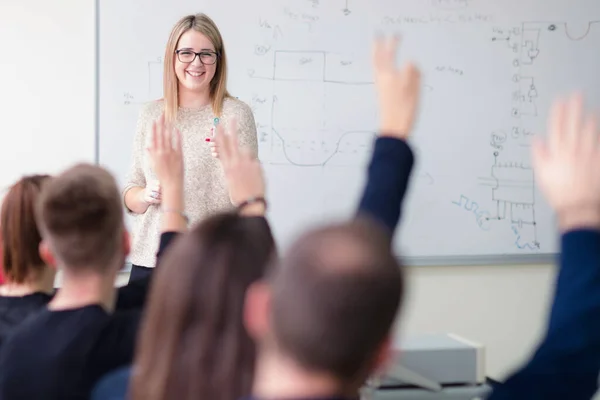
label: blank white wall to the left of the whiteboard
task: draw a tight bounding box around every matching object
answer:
[0,0,95,193]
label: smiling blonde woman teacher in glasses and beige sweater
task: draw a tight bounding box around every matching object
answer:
[123,14,258,280]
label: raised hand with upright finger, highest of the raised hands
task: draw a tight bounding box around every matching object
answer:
[373,36,421,139]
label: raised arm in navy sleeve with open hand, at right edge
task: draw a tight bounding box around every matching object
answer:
[490,95,600,400]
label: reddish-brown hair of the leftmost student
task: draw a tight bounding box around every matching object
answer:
[0,175,50,284]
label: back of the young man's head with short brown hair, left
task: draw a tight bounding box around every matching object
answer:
[37,164,125,273]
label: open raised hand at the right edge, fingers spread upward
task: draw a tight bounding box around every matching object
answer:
[532,94,600,231]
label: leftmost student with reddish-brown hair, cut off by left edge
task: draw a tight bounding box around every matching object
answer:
[0,175,56,345]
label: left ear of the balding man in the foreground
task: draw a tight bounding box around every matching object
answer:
[244,281,271,341]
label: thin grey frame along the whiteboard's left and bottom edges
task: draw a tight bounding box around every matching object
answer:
[94,0,560,271]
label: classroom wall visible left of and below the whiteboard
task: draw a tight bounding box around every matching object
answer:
[0,0,554,378]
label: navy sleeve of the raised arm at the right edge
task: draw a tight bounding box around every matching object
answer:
[489,230,600,400]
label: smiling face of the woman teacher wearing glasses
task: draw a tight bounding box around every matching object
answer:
[174,29,218,93]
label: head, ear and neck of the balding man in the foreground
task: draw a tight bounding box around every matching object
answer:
[246,219,404,399]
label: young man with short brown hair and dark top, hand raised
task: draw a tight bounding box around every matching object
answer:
[0,120,185,400]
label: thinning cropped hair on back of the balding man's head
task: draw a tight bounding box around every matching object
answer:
[271,220,403,388]
